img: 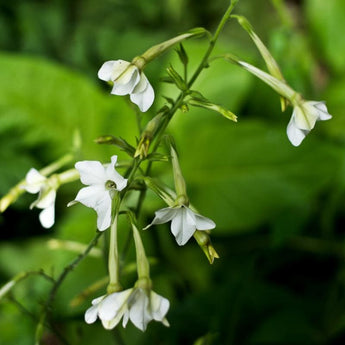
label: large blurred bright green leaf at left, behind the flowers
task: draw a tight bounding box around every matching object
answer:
[0,53,136,193]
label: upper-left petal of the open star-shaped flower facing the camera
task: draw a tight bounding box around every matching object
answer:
[75,161,107,185]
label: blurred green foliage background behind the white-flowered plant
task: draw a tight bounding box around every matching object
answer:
[0,0,345,345]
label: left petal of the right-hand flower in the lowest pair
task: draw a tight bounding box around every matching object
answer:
[129,288,152,331]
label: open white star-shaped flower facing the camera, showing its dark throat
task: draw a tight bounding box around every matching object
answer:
[75,156,127,231]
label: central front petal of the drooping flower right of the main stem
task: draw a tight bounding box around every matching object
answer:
[171,206,196,246]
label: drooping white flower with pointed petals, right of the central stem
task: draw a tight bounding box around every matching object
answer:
[145,205,216,246]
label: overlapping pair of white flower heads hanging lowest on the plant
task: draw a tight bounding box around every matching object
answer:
[85,288,170,331]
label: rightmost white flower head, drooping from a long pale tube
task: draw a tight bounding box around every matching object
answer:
[286,101,332,146]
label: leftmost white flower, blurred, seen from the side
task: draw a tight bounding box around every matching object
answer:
[23,168,58,229]
